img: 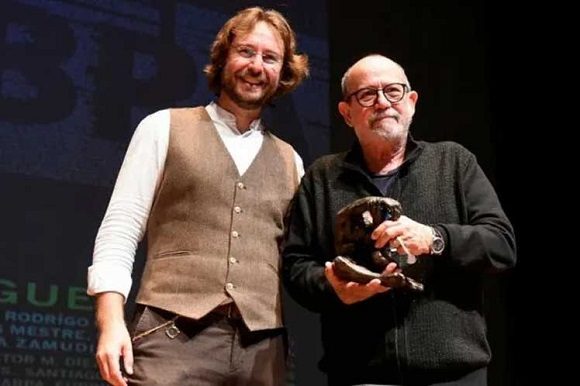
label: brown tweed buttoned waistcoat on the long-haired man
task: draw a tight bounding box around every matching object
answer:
[137,107,298,330]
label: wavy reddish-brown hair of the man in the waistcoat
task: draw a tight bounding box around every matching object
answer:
[203,7,308,96]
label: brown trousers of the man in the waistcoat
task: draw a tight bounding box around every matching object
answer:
[128,307,286,386]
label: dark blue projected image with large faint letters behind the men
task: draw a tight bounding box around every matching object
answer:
[0,0,329,187]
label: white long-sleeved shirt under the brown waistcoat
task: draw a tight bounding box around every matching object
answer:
[87,102,304,299]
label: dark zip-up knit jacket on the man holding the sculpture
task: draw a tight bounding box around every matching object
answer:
[282,138,516,385]
